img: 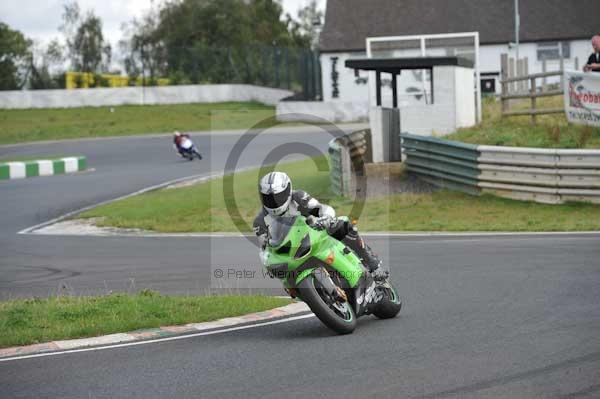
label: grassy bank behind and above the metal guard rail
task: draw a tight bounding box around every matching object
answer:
[444,96,600,148]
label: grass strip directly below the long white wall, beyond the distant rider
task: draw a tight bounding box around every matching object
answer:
[0,102,275,144]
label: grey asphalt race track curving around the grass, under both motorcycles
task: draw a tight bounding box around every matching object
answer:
[0,128,600,398]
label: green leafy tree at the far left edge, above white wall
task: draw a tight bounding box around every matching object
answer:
[0,22,32,90]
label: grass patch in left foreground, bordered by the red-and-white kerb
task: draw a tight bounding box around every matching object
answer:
[0,290,291,347]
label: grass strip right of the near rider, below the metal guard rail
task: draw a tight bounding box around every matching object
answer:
[334,190,600,232]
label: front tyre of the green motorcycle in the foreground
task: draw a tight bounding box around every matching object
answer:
[298,274,356,334]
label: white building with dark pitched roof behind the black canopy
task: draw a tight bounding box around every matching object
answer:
[319,0,600,103]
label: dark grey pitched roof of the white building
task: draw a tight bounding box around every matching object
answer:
[320,0,600,52]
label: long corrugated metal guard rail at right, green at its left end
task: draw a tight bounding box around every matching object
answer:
[400,133,600,204]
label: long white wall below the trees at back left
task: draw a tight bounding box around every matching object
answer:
[0,84,293,109]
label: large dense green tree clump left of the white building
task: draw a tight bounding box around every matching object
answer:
[120,0,316,86]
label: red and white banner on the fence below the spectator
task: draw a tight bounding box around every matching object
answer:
[564,71,600,126]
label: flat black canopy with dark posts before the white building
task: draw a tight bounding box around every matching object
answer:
[345,57,473,108]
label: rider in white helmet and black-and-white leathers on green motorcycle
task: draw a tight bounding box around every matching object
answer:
[253,172,389,280]
